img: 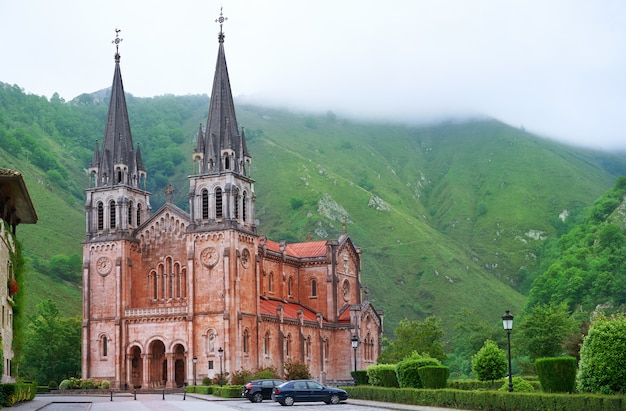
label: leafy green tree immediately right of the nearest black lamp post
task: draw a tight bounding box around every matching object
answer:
[518,303,577,360]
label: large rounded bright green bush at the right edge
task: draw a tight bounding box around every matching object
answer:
[578,314,626,394]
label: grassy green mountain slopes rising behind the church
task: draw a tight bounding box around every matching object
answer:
[0,83,626,335]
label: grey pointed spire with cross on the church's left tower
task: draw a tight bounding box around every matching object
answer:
[90,29,145,188]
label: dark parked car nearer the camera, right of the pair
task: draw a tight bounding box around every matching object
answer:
[272,380,348,405]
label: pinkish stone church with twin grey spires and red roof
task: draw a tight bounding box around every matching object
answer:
[82,15,383,389]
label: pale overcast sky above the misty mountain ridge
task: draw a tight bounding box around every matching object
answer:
[0,0,626,149]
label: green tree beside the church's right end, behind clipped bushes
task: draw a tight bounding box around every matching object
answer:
[378,316,446,364]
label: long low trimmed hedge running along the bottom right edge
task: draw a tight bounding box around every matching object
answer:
[343,386,626,411]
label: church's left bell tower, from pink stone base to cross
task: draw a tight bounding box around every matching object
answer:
[82,30,151,386]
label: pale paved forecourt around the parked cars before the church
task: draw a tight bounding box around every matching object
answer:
[11,393,462,411]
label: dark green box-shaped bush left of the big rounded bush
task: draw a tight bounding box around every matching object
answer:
[535,357,578,392]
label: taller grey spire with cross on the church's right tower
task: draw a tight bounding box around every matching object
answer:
[196,10,251,176]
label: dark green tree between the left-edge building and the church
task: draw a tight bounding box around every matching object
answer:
[21,300,81,384]
